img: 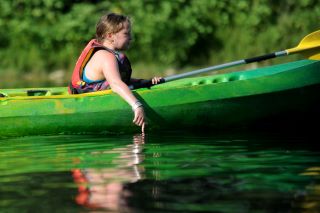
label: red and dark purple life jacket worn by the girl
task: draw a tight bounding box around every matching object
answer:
[68,39,132,94]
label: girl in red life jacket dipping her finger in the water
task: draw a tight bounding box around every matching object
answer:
[69,13,161,132]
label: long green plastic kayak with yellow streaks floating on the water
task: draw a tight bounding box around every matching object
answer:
[0,60,320,137]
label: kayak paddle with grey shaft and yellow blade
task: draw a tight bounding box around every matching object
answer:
[130,30,320,89]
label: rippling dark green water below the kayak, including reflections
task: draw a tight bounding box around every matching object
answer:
[0,132,320,213]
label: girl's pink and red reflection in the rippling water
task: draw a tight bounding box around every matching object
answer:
[72,134,145,212]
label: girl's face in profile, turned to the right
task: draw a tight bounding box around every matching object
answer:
[113,22,132,50]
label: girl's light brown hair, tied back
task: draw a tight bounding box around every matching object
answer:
[96,13,130,42]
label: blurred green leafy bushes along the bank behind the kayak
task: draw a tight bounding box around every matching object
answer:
[0,0,320,88]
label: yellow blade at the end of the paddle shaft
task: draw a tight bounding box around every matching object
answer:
[287,30,320,60]
